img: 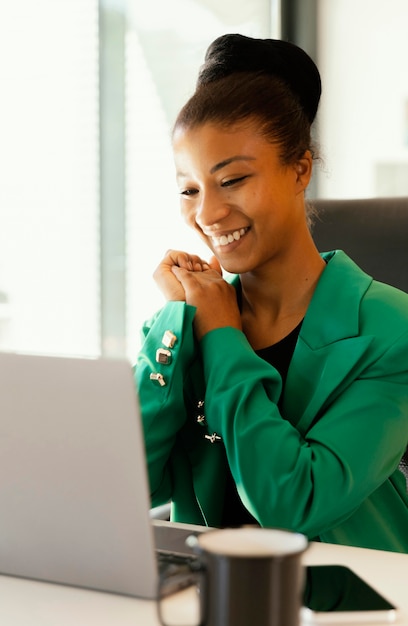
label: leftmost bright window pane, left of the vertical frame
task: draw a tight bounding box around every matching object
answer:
[0,0,100,354]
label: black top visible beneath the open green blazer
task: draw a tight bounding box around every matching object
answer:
[222,322,302,526]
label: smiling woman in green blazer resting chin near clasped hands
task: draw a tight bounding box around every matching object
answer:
[135,35,408,552]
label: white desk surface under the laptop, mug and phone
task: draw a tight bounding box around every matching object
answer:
[0,543,408,626]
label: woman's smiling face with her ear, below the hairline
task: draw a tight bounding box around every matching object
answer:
[173,123,311,273]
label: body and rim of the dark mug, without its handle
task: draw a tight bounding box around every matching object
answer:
[183,526,308,626]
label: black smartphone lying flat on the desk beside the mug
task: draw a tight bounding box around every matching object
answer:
[302,565,396,623]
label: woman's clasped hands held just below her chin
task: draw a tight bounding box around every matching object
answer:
[153,250,241,339]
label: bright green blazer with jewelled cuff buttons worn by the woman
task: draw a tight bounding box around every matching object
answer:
[135,251,408,552]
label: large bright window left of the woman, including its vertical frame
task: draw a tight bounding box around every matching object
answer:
[0,0,276,360]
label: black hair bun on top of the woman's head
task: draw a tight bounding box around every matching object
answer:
[197,34,322,123]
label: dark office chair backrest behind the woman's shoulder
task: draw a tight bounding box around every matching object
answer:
[311,197,408,491]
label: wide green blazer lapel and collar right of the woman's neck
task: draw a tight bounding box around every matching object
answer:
[282,251,372,433]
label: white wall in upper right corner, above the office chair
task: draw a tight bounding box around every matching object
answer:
[318,0,408,198]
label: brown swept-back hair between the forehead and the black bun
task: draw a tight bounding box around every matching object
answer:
[174,72,313,164]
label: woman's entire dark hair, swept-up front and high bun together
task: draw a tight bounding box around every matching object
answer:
[174,34,321,164]
